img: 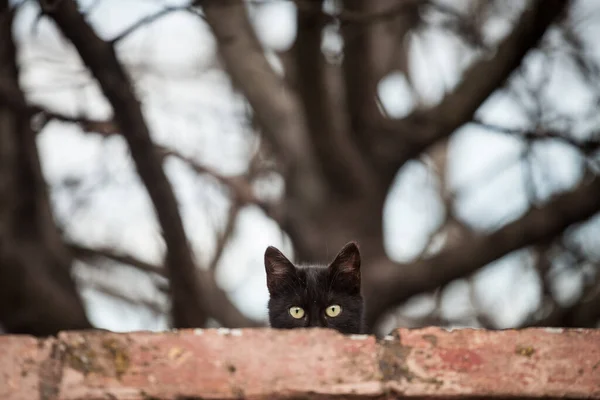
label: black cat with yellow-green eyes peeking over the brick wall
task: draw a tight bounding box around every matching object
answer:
[265,242,364,334]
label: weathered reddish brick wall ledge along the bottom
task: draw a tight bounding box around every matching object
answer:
[0,328,600,400]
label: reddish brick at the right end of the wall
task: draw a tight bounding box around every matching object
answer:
[388,328,600,398]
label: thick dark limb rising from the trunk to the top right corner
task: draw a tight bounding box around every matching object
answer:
[377,0,570,179]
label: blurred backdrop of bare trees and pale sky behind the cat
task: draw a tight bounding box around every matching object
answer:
[0,0,600,335]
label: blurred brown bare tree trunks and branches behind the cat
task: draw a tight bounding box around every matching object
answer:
[0,0,600,334]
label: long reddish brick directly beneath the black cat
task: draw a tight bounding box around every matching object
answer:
[60,329,380,399]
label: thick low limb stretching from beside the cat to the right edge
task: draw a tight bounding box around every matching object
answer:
[365,170,600,323]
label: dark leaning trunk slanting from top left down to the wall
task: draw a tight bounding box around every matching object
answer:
[40,0,210,327]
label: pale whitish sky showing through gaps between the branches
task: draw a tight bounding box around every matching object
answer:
[8,0,600,331]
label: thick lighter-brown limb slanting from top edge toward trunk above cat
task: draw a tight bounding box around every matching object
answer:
[196,0,326,205]
